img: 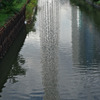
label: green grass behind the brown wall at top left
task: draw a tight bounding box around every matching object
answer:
[0,0,26,27]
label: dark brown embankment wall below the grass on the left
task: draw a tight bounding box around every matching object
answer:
[0,6,26,59]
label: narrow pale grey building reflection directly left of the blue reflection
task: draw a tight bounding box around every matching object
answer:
[72,6,79,64]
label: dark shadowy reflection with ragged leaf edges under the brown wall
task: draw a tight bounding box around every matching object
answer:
[0,25,27,92]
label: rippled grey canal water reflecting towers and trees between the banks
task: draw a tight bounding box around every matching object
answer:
[0,0,100,100]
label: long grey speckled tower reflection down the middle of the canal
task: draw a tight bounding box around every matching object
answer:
[40,0,59,100]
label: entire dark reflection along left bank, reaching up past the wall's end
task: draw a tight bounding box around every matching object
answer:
[0,3,37,97]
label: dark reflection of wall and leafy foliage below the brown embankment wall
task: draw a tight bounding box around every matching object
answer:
[0,27,26,92]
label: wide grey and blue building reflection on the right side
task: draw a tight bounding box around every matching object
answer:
[72,3,100,66]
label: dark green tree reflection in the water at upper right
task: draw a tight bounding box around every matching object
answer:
[70,0,100,31]
